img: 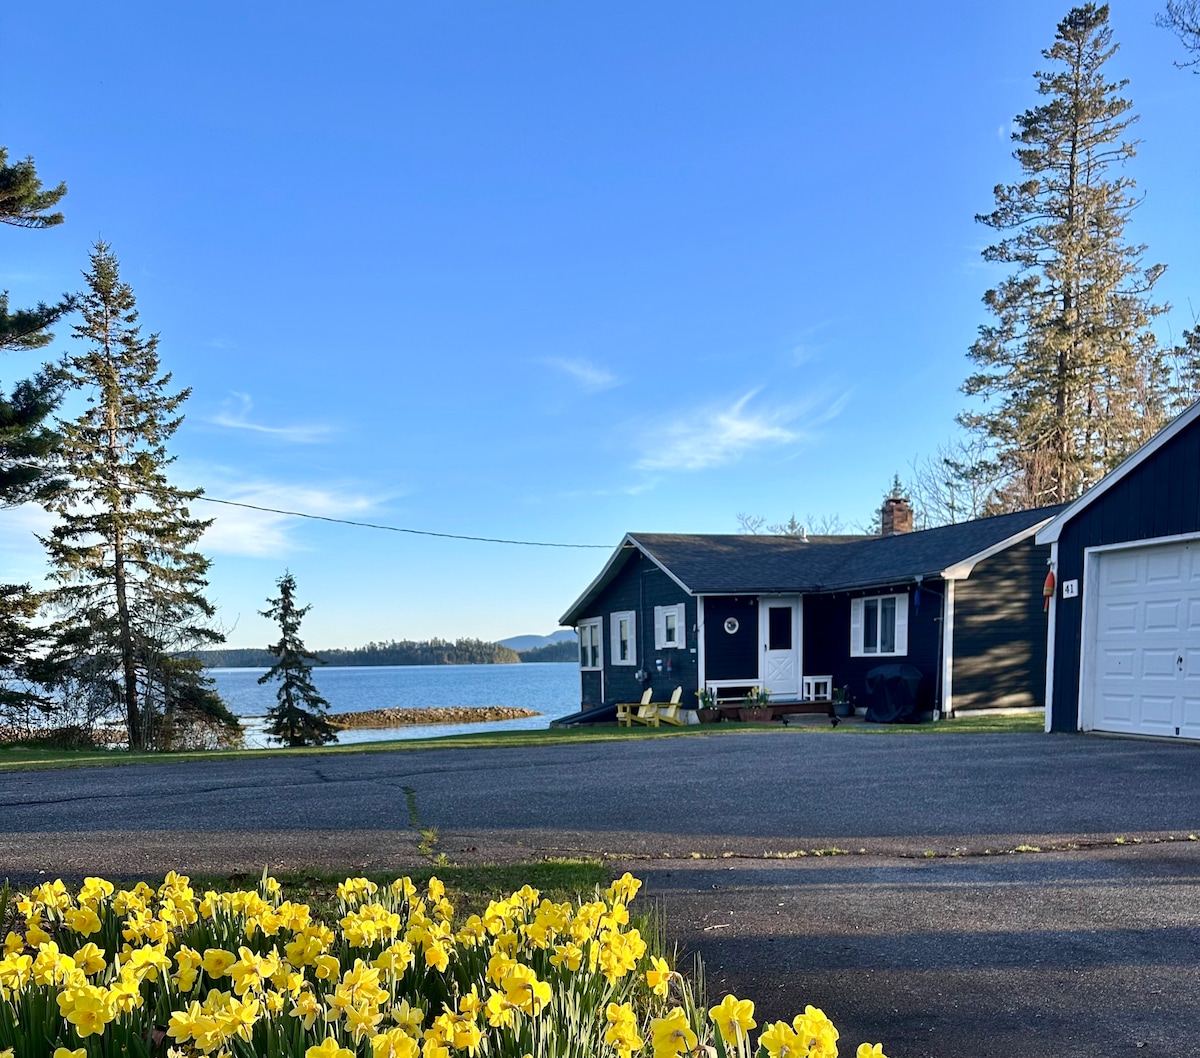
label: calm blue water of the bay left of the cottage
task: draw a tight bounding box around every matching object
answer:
[209,662,580,747]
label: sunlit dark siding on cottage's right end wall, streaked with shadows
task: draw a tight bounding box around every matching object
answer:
[952,537,1050,713]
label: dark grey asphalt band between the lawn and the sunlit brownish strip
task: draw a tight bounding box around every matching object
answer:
[0,733,1200,841]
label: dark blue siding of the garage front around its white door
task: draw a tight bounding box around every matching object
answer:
[1051,420,1200,731]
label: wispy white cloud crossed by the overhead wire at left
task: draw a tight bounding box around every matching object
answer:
[192,481,377,558]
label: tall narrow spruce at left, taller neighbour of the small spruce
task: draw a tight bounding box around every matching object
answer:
[42,242,236,750]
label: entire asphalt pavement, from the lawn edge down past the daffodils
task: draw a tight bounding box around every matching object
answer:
[0,732,1200,1058]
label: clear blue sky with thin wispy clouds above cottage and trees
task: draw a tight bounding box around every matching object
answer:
[0,0,1200,647]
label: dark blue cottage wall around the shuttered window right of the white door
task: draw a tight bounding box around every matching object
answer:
[803,581,942,713]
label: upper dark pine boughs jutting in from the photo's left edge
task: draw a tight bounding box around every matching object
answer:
[0,148,74,506]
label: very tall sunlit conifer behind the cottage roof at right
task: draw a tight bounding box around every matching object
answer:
[959,4,1170,510]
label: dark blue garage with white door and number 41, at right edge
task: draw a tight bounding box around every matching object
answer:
[1037,404,1200,739]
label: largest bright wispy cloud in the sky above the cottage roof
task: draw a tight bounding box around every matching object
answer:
[635,390,846,470]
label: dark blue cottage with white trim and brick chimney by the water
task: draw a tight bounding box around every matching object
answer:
[562,499,1061,720]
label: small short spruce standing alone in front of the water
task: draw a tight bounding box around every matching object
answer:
[258,571,337,746]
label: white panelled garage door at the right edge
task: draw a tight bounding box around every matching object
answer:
[1082,540,1200,739]
